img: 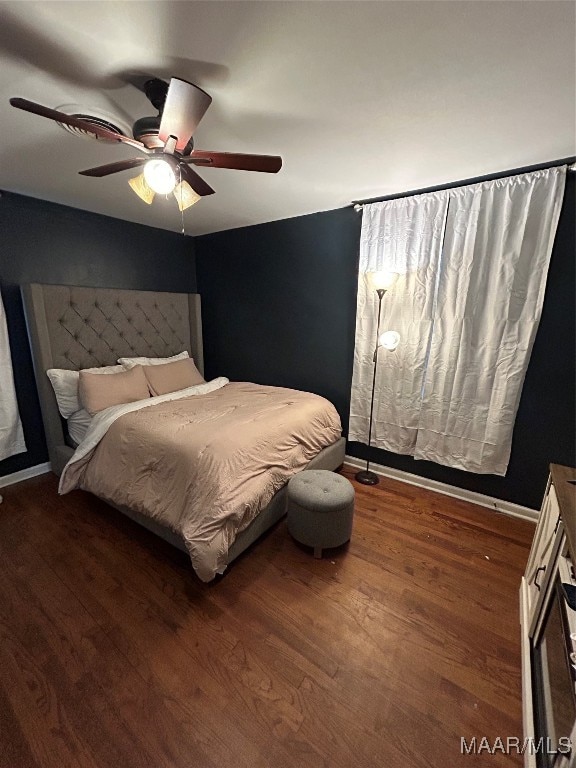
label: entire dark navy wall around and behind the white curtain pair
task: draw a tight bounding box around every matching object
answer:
[195,174,576,509]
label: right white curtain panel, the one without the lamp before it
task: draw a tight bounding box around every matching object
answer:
[414,167,566,475]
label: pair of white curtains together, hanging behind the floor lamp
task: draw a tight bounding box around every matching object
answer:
[349,168,566,475]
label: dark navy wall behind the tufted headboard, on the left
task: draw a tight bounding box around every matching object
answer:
[0,193,196,477]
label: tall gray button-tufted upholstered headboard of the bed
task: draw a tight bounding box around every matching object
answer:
[22,283,204,474]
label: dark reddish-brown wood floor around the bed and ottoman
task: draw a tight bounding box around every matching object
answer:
[0,471,534,768]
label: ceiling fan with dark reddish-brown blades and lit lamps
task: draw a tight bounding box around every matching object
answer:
[10,77,282,211]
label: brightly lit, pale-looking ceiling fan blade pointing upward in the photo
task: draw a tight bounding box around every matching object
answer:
[158,77,212,152]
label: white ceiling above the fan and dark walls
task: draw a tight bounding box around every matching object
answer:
[0,0,576,235]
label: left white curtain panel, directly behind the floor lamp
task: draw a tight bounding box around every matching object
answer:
[348,192,448,453]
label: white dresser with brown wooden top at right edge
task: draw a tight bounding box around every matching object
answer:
[520,464,576,768]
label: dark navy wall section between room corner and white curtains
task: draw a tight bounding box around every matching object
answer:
[194,209,360,423]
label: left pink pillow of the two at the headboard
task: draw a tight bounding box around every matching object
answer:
[78,365,150,416]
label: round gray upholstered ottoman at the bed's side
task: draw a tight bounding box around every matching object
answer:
[288,469,354,557]
